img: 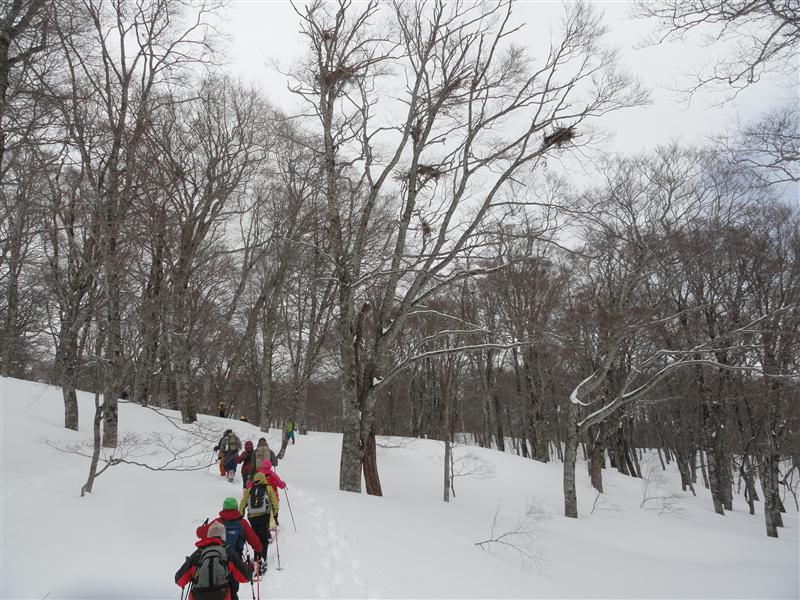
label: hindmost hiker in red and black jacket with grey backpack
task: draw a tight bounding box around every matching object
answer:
[175,521,253,600]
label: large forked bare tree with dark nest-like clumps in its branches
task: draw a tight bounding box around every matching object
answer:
[293,1,645,494]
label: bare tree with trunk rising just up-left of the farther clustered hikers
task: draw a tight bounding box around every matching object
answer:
[148,79,269,423]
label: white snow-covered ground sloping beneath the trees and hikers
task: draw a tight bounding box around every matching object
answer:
[0,379,800,599]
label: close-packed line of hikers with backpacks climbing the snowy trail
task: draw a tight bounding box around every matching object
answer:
[175,429,287,600]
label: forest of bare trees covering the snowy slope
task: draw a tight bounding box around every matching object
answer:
[0,0,800,537]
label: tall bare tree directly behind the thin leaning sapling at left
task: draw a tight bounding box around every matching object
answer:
[52,0,217,447]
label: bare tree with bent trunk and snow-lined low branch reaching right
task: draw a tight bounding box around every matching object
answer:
[564,147,740,517]
